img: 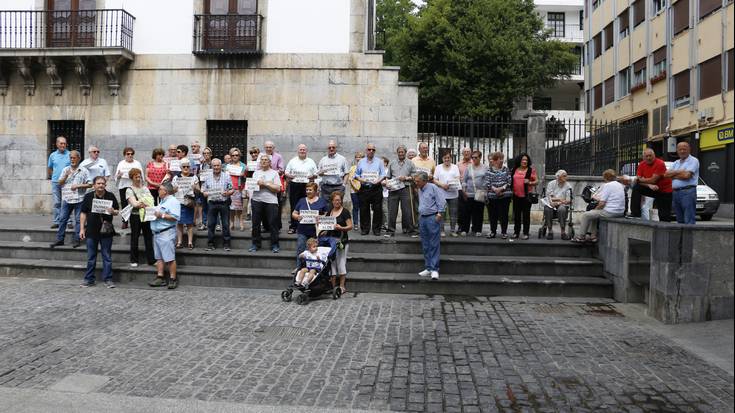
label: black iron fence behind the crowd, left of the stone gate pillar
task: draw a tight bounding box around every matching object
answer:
[418,116,528,163]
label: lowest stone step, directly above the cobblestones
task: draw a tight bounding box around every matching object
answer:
[0,258,612,300]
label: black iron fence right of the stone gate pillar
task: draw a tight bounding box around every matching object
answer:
[546,119,648,176]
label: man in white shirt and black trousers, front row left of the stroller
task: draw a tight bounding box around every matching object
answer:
[248,156,281,253]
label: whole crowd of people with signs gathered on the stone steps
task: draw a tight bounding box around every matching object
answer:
[48,137,699,286]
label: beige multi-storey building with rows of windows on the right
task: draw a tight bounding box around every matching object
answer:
[583,0,735,203]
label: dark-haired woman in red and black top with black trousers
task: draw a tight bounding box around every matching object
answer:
[511,153,538,240]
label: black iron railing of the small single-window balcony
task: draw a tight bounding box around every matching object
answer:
[194,14,263,54]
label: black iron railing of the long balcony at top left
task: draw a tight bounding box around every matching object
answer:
[0,9,135,51]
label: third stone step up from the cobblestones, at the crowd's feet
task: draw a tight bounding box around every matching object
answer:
[0,229,594,258]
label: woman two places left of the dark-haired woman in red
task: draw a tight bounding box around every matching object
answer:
[459,151,487,237]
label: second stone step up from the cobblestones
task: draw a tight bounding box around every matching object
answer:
[0,241,602,277]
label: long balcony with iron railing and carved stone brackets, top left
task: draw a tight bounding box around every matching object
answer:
[0,9,135,96]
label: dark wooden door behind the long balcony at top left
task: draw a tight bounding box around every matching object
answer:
[47,0,97,47]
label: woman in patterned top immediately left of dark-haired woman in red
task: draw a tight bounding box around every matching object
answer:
[485,152,513,239]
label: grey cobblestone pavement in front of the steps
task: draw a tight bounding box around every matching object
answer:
[0,278,734,412]
